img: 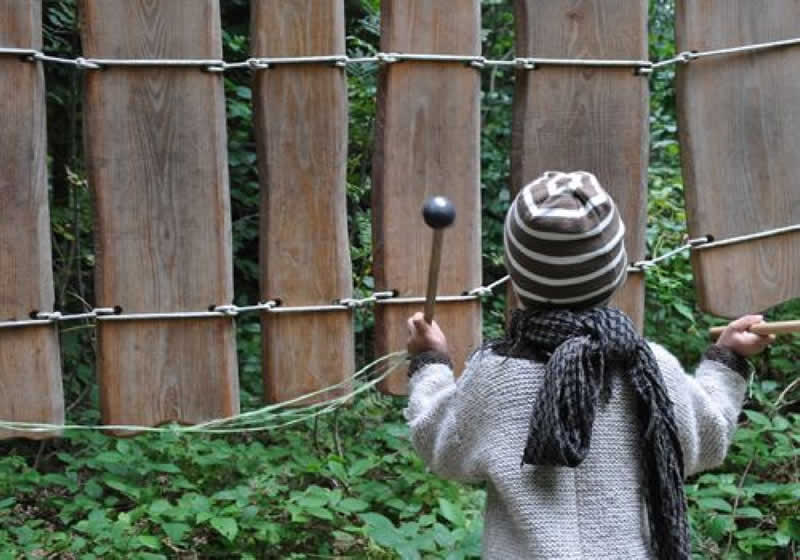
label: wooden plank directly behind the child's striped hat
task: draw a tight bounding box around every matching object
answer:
[511,0,649,330]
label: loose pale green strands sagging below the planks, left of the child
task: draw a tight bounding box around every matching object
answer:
[0,352,407,434]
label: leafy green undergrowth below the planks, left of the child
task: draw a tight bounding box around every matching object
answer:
[0,395,483,559]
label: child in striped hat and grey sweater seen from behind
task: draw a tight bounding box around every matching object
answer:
[406,172,773,560]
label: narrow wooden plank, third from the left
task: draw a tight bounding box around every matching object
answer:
[251,0,355,405]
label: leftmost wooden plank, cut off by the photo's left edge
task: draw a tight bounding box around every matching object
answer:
[0,0,64,439]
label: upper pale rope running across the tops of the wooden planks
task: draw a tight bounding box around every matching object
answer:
[0,37,800,75]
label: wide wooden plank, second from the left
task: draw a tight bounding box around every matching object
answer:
[80,0,239,434]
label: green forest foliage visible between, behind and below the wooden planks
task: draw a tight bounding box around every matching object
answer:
[0,0,800,560]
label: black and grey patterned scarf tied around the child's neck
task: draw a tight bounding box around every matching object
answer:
[490,307,691,560]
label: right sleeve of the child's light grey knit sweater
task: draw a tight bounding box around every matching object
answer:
[651,344,747,476]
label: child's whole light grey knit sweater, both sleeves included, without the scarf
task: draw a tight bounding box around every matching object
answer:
[405,344,746,560]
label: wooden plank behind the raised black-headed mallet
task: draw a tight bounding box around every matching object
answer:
[372,0,481,394]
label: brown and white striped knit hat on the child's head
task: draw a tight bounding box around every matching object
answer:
[503,171,628,309]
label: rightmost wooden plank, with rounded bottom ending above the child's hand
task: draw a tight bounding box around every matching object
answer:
[676,0,800,317]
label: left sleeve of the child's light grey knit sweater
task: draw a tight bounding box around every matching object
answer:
[404,352,484,482]
